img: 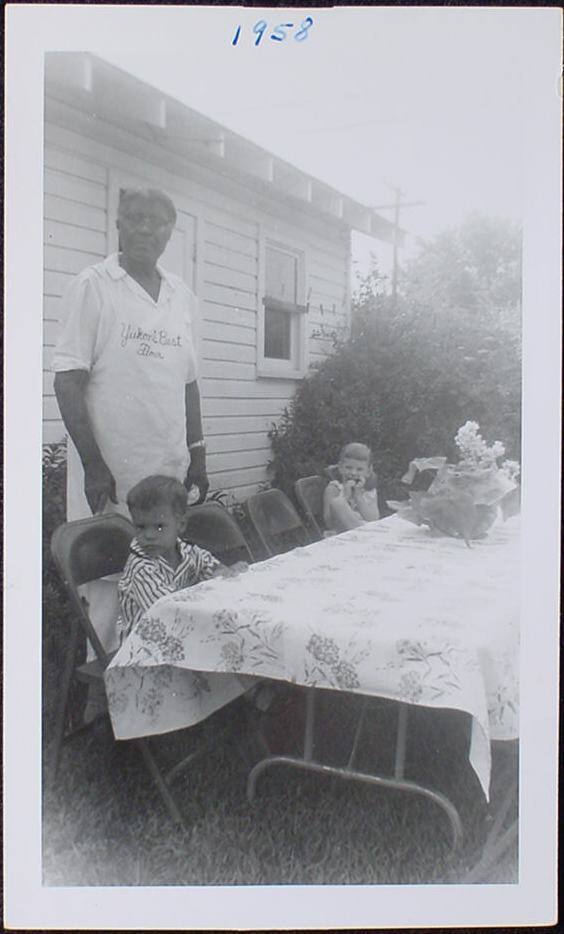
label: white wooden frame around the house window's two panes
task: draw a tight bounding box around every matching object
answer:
[257,232,308,379]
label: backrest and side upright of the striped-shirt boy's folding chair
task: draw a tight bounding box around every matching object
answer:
[51,513,134,661]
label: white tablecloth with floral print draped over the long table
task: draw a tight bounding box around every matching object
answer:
[106,516,520,796]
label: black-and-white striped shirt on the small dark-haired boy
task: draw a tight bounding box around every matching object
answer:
[118,538,220,636]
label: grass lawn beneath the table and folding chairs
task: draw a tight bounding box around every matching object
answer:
[43,689,517,886]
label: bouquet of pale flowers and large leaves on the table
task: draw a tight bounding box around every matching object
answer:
[388,422,519,545]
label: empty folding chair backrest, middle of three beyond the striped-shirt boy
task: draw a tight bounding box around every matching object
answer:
[245,490,309,555]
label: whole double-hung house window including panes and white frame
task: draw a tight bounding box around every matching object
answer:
[258,242,306,378]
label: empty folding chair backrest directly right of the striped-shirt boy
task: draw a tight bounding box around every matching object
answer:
[184,503,254,564]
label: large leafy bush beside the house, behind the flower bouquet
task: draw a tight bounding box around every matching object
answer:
[269,217,521,496]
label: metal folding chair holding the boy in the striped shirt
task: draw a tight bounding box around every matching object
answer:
[51,514,198,825]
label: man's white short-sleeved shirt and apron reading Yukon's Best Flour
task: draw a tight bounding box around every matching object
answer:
[53,254,197,515]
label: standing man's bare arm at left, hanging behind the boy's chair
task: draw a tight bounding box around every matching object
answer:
[55,370,117,513]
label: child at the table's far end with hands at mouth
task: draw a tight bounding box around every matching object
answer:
[323,442,380,533]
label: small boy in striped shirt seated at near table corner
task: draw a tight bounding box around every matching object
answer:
[118,475,246,638]
